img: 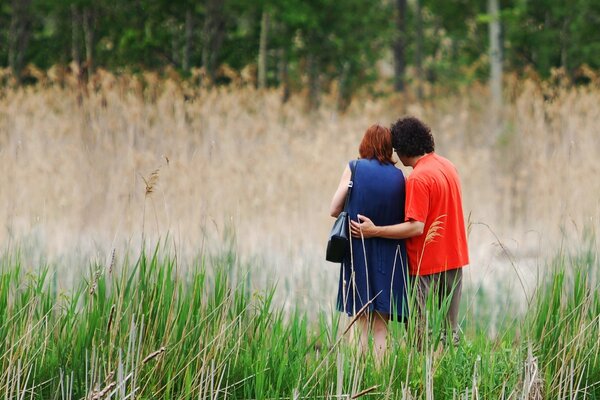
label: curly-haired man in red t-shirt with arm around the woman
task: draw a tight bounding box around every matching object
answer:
[351,117,469,344]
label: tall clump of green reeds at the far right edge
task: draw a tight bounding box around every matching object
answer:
[523,236,600,398]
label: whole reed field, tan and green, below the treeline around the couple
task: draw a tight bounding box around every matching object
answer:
[0,70,600,399]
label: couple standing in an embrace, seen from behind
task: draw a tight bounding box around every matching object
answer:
[331,117,469,358]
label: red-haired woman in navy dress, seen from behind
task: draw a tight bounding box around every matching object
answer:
[331,125,408,358]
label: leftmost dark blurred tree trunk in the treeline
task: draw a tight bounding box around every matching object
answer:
[8,0,31,84]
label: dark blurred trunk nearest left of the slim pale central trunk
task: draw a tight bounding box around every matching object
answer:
[202,0,225,82]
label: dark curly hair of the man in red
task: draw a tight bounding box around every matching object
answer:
[390,117,435,157]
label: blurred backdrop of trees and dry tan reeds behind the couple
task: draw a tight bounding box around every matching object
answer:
[0,0,600,306]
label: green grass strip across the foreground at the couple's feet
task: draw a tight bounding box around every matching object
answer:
[0,236,600,399]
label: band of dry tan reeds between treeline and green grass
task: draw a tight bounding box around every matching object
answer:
[0,71,600,304]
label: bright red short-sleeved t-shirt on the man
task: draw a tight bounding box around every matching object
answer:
[406,153,469,275]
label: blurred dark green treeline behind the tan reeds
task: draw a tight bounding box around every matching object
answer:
[0,0,600,103]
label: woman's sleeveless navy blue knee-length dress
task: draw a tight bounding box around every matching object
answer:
[337,159,408,321]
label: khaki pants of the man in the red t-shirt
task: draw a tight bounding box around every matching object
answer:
[412,268,462,344]
